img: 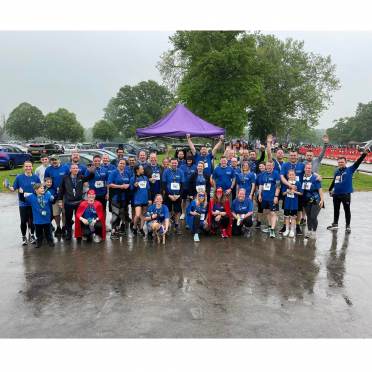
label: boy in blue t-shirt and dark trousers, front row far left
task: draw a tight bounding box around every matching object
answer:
[26,183,54,248]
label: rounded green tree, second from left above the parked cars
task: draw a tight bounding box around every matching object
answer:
[45,108,84,141]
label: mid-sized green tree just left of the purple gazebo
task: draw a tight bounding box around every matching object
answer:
[104,80,173,137]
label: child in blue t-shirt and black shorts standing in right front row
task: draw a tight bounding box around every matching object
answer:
[283,169,302,238]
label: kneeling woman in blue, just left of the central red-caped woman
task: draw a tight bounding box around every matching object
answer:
[186,192,208,242]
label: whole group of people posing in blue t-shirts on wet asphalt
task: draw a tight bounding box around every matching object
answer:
[9,135,369,247]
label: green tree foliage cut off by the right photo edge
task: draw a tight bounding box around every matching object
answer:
[327,101,372,144]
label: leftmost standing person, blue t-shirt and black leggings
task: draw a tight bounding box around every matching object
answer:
[9,161,40,245]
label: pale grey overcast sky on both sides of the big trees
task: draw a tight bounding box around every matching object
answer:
[0,31,372,128]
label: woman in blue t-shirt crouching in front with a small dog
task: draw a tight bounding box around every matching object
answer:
[145,194,170,244]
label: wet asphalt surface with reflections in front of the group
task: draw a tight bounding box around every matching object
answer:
[0,193,372,338]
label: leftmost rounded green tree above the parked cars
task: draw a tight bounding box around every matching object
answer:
[5,102,44,141]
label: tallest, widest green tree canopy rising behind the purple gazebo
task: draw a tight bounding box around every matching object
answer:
[158,31,339,139]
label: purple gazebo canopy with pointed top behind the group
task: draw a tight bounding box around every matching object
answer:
[136,103,225,137]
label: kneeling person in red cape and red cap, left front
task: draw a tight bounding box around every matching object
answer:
[75,190,106,243]
